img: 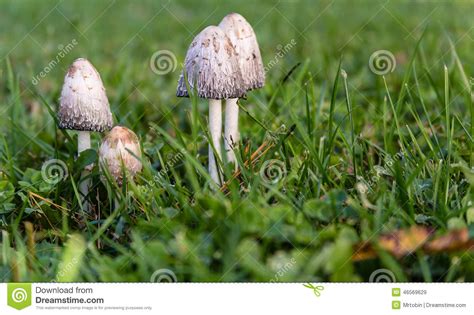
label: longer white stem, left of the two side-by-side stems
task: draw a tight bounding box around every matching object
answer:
[209,99,222,185]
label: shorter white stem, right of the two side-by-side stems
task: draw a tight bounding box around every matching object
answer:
[224,98,239,169]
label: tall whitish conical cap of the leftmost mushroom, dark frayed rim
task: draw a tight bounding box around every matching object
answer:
[58,58,112,132]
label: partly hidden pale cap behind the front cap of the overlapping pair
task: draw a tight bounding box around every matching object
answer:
[219,13,265,91]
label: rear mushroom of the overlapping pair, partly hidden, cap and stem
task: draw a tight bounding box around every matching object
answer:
[219,13,265,168]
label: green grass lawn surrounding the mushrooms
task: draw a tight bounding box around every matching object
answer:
[0,1,474,282]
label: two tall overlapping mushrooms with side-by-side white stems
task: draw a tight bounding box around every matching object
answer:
[176,13,265,184]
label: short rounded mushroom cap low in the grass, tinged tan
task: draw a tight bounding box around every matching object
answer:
[99,126,142,185]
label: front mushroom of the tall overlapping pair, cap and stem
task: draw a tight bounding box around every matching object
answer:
[176,26,245,184]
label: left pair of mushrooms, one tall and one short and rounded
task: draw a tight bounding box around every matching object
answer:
[58,58,142,197]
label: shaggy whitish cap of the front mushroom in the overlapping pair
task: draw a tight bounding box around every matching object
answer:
[176,26,246,99]
